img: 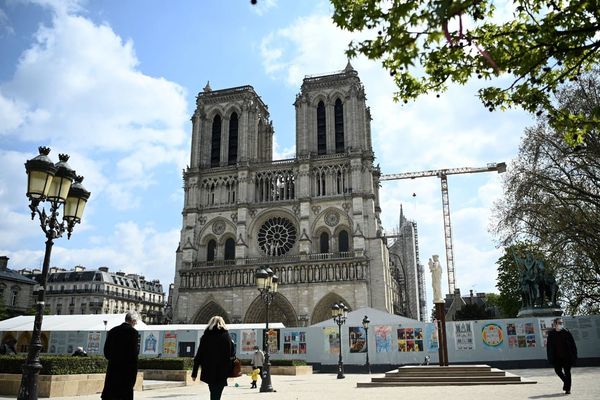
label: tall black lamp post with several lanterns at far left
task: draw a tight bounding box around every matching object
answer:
[17,147,90,400]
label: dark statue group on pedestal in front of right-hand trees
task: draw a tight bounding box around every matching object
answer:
[512,251,560,310]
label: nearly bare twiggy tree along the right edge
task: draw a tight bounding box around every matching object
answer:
[494,69,600,314]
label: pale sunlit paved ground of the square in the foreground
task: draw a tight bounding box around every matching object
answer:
[0,367,600,400]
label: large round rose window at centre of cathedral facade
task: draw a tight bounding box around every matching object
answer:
[258,217,296,256]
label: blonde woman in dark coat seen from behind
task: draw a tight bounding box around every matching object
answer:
[192,315,235,400]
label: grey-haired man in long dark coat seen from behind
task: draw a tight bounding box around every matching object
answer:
[101,311,139,400]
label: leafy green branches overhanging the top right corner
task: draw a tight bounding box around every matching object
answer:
[331,0,600,144]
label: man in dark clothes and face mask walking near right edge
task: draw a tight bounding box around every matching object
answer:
[546,318,577,394]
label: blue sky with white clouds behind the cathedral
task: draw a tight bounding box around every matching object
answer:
[0,0,533,310]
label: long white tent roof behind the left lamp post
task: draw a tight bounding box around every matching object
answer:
[0,313,146,332]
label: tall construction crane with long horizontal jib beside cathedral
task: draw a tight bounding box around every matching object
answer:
[379,162,506,294]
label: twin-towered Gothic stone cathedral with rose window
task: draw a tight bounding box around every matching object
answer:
[172,63,424,327]
